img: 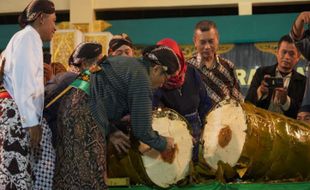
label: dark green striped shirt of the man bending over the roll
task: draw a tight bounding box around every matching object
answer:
[90,56,166,151]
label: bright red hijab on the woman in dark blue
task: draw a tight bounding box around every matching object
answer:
[157,38,187,89]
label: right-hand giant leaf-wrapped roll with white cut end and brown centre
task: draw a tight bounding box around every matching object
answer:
[195,100,310,181]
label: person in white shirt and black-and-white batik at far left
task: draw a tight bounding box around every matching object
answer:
[0,0,56,189]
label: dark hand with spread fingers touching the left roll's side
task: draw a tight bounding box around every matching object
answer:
[109,131,130,154]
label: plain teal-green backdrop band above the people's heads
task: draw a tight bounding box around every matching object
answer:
[0,13,297,49]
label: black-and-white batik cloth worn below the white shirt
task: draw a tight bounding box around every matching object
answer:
[0,98,55,190]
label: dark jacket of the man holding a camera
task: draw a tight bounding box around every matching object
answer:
[245,64,306,119]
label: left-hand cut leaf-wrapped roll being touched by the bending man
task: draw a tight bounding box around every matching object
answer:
[108,109,193,188]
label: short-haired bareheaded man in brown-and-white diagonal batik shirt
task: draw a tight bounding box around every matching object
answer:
[188,20,243,104]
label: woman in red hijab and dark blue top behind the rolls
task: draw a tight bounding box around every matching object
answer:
[153,38,211,162]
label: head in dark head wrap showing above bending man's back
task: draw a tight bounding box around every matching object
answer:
[109,33,134,57]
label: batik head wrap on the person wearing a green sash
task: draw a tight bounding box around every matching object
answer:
[69,42,102,66]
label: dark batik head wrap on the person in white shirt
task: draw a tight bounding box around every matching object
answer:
[18,0,55,28]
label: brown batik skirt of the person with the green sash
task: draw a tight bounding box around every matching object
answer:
[54,89,107,190]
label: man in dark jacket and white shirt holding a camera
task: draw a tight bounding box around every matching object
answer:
[245,35,306,118]
